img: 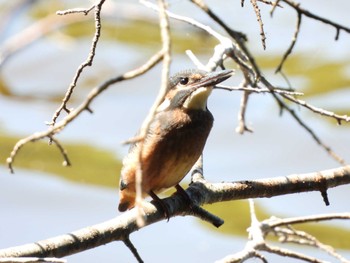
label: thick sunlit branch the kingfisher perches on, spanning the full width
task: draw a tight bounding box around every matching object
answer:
[0,166,350,258]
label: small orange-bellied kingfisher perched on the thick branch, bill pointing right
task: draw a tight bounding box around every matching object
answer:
[118,69,233,220]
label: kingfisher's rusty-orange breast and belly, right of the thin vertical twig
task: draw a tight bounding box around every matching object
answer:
[142,111,213,193]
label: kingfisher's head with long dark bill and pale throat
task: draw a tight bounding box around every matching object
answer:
[158,69,233,111]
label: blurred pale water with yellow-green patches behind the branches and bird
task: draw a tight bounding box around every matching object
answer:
[0,0,350,263]
